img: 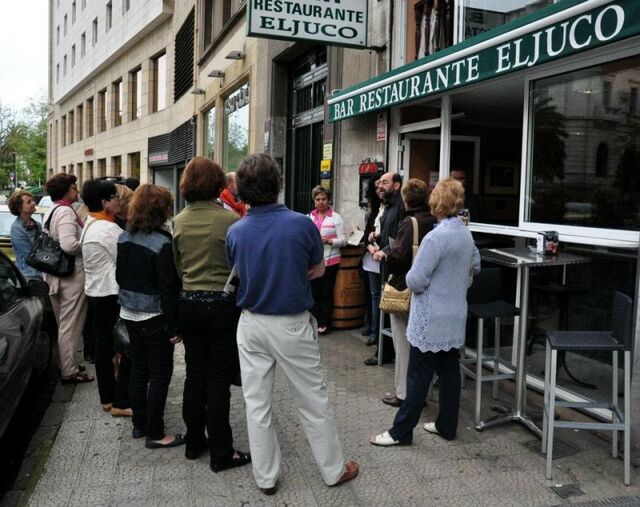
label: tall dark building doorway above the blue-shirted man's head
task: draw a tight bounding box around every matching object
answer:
[285,48,329,213]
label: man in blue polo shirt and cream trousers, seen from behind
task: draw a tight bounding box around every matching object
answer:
[226,154,358,495]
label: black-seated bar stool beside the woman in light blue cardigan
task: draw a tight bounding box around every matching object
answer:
[460,268,520,430]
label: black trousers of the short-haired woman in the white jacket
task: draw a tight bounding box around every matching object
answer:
[87,295,131,408]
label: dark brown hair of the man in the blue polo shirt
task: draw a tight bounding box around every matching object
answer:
[236,153,282,206]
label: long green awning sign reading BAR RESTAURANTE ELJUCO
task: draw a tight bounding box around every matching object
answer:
[328,0,640,122]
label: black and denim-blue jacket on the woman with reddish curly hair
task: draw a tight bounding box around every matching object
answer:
[116,230,181,336]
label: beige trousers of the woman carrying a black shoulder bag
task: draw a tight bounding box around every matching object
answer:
[49,266,87,377]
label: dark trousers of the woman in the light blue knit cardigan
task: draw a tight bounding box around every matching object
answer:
[389,346,461,444]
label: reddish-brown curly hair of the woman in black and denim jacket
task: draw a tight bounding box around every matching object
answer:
[127,183,173,232]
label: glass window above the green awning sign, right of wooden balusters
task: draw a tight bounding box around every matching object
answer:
[461,0,559,40]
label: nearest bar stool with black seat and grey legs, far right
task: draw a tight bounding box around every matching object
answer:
[542,292,633,486]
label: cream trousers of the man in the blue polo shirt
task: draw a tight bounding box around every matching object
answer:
[238,310,345,488]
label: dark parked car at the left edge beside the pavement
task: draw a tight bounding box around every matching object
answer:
[0,252,51,436]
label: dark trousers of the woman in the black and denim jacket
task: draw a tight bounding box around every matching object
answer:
[125,315,173,440]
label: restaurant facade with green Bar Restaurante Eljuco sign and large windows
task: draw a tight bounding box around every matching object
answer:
[327,0,640,418]
